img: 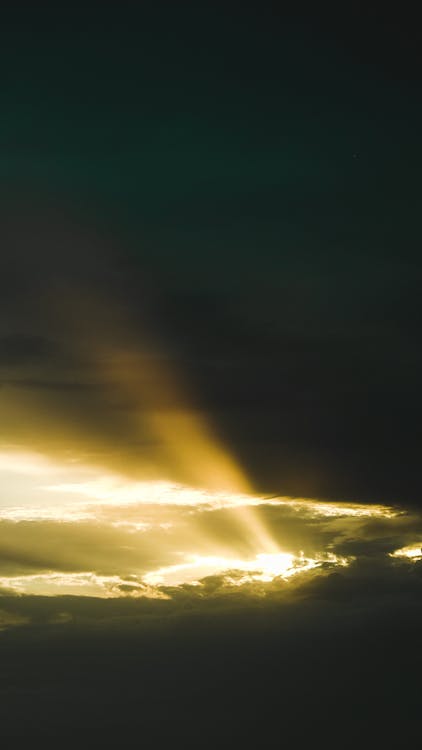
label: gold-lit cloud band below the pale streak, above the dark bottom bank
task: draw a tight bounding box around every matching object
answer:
[0,488,422,613]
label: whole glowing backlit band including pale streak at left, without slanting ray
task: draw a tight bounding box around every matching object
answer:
[0,447,422,612]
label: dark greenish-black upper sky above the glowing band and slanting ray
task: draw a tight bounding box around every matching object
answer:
[0,3,422,503]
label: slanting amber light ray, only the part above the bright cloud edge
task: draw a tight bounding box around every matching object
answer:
[50,289,250,492]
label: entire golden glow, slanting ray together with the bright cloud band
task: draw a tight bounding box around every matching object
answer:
[0,270,412,612]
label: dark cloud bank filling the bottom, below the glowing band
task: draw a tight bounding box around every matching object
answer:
[0,552,422,747]
